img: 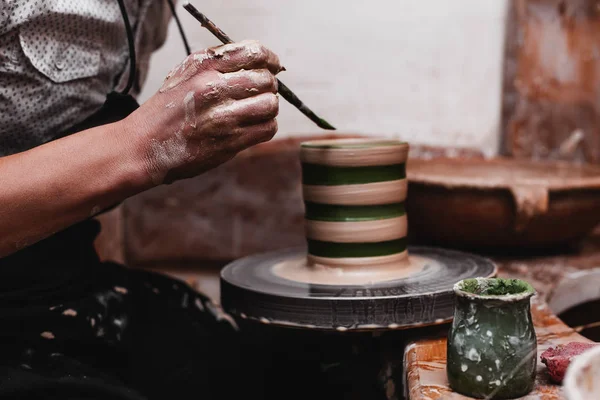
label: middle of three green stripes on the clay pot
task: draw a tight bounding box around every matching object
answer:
[304,202,406,222]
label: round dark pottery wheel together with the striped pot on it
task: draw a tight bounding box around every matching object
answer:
[221,139,496,332]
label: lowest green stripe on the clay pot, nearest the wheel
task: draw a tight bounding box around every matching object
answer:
[307,238,406,258]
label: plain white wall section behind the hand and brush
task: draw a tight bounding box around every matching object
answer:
[141,0,507,154]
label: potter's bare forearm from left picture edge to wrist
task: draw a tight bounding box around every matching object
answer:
[0,117,152,257]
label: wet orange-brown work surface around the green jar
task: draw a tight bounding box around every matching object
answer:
[404,236,600,400]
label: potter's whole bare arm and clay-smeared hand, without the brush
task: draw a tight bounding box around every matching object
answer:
[0,41,282,257]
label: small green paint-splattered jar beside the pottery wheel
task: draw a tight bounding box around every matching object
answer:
[447,278,537,399]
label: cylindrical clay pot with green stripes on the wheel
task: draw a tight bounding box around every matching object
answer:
[300,139,409,267]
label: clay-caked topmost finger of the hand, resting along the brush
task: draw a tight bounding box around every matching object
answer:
[160,41,283,93]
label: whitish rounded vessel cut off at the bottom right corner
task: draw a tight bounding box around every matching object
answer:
[563,346,600,400]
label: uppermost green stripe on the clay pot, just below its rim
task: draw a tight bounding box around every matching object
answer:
[302,163,406,186]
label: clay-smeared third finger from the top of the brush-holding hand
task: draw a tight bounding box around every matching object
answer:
[203,93,279,131]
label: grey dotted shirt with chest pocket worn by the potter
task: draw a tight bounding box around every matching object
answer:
[0,0,170,156]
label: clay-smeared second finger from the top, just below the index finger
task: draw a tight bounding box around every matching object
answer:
[202,69,277,101]
